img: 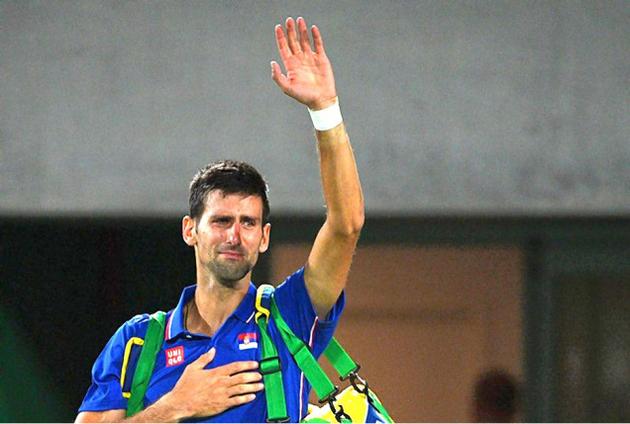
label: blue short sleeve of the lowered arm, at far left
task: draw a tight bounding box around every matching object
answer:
[79,314,149,412]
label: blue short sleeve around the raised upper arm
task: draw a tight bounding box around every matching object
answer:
[274,267,345,356]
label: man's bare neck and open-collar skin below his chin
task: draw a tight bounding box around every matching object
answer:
[186,272,251,336]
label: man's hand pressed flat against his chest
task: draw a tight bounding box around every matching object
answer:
[166,349,263,417]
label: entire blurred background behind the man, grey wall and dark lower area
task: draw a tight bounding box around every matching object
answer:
[0,0,630,422]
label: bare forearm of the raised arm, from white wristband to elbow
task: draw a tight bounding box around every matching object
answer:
[316,122,364,236]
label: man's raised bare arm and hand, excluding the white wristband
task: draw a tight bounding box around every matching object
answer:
[271,18,364,318]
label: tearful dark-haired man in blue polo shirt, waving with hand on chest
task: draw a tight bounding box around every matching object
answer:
[77,18,364,422]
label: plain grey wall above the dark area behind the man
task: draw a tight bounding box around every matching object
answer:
[0,0,630,216]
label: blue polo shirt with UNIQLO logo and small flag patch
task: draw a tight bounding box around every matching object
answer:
[79,268,345,422]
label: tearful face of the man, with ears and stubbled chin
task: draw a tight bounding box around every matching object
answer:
[182,190,271,288]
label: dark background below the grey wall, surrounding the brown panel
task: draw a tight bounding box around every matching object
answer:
[0,216,630,421]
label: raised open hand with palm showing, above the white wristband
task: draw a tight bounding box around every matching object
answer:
[271,18,337,110]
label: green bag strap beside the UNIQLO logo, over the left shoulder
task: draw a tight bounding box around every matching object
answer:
[127,311,166,417]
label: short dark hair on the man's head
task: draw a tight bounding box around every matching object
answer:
[188,160,270,224]
